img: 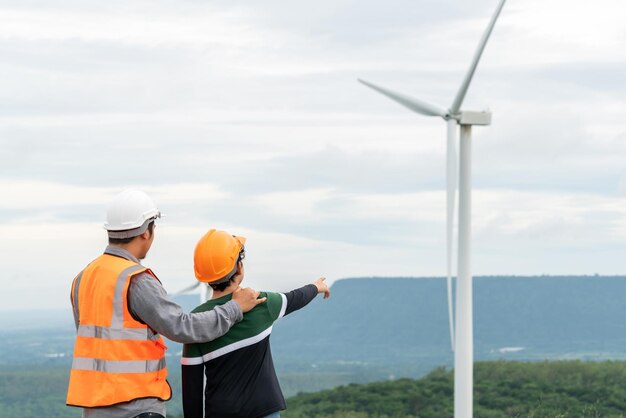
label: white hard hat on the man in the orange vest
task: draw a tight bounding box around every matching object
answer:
[104,189,161,238]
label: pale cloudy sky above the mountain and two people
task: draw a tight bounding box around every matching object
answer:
[0,0,626,310]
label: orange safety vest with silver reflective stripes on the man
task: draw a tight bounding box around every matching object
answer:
[67,254,172,408]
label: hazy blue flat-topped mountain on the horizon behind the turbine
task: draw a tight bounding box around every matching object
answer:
[272,276,626,371]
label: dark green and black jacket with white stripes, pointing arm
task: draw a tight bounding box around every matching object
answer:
[181,284,317,418]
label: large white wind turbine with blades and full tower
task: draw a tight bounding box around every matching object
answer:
[359,0,506,418]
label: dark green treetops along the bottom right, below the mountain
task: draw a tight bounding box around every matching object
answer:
[281,361,626,418]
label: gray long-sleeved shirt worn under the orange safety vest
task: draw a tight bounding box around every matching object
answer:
[74,245,243,418]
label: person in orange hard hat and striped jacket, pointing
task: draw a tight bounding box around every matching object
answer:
[182,229,330,418]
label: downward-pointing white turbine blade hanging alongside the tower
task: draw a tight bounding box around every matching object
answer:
[446,119,458,351]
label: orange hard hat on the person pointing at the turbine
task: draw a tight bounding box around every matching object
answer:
[193,229,246,283]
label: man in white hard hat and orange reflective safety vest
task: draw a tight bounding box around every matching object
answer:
[67,190,265,418]
